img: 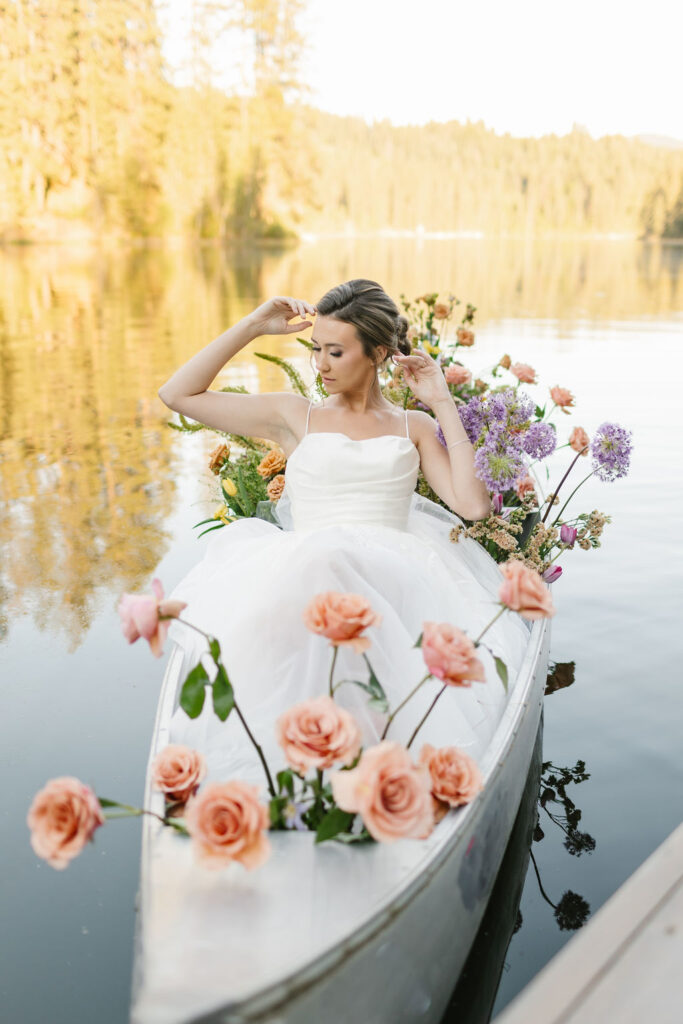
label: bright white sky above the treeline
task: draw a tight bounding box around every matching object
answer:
[161,0,683,140]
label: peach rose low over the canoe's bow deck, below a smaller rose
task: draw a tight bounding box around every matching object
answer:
[185,779,270,870]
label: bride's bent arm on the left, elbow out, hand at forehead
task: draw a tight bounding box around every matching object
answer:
[158,295,315,440]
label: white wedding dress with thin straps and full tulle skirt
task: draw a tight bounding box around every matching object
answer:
[168,406,528,784]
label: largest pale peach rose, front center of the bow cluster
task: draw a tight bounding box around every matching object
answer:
[330,739,434,843]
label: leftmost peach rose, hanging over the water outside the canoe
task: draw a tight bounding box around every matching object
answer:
[27,775,104,871]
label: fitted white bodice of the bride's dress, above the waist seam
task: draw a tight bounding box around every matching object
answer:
[286,431,420,531]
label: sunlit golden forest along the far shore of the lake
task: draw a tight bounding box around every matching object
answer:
[0,0,683,243]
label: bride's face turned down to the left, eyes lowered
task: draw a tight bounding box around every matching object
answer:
[310,316,385,394]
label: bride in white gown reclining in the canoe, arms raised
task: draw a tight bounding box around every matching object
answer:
[159,279,528,782]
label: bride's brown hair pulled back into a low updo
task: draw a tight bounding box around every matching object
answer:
[315,278,411,366]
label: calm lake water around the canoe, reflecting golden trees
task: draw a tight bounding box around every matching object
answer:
[0,239,683,1024]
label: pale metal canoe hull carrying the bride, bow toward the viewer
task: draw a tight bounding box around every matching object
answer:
[131,620,550,1024]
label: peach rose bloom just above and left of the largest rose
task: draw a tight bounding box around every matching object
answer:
[275,696,361,775]
